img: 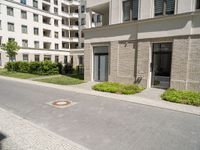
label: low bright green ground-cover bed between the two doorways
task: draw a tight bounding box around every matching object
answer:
[92,82,144,95]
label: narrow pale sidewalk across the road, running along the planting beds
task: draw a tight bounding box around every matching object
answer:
[0,76,200,115]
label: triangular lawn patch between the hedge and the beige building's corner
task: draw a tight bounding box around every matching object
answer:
[36,75,84,85]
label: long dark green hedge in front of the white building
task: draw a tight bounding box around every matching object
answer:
[5,61,59,75]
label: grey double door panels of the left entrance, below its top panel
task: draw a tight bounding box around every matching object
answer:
[94,53,108,81]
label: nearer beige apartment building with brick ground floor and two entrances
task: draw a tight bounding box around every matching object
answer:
[84,0,200,91]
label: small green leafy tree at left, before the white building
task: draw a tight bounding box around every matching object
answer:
[2,40,20,61]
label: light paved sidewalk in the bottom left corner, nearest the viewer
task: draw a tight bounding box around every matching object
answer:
[0,108,88,150]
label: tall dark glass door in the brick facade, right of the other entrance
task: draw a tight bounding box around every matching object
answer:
[151,43,172,89]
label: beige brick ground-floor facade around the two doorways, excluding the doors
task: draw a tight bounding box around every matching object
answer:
[85,36,200,91]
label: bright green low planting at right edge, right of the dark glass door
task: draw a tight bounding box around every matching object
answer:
[161,89,200,106]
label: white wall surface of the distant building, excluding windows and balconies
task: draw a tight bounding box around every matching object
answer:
[0,0,83,66]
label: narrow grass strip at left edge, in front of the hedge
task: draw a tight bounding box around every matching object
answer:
[0,69,40,79]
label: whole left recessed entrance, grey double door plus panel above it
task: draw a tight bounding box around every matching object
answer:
[93,46,108,82]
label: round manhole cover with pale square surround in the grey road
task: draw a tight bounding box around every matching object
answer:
[48,99,76,108]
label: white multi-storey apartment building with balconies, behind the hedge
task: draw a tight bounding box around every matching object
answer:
[0,0,84,67]
